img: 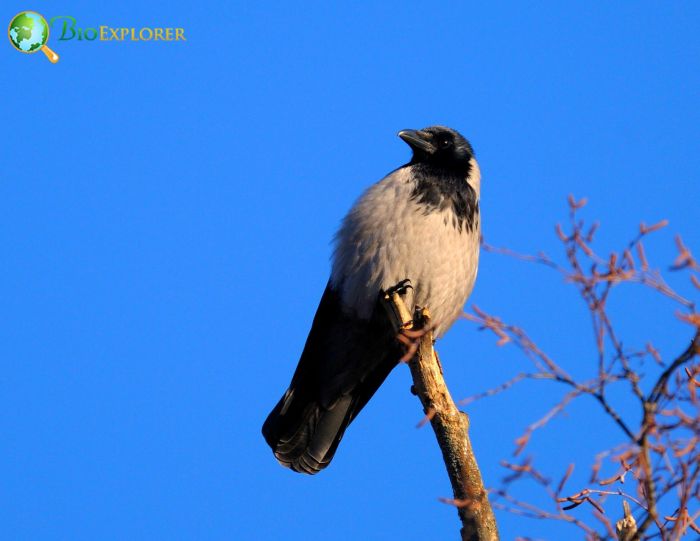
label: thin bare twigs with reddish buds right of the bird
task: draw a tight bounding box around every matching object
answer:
[465,196,700,541]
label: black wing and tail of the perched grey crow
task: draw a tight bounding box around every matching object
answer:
[262,285,401,475]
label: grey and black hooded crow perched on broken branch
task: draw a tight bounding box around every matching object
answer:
[263,126,481,474]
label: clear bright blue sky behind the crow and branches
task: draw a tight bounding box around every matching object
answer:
[0,0,700,540]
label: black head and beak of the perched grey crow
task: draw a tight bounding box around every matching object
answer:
[399,126,474,170]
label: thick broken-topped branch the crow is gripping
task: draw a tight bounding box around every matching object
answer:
[384,292,498,541]
